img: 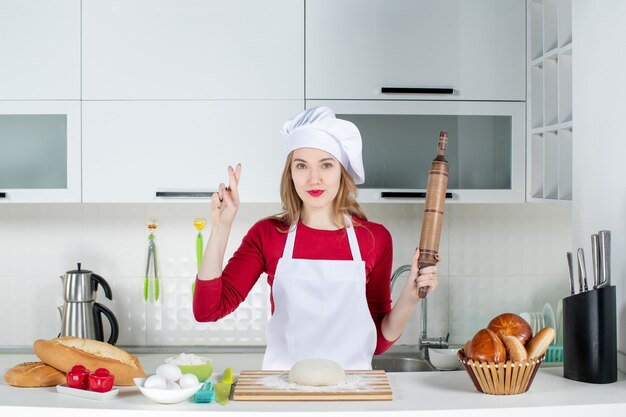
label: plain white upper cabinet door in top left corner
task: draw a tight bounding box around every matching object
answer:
[0,0,80,100]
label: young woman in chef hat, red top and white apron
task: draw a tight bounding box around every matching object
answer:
[193,107,437,369]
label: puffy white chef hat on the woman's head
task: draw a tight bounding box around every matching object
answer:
[280,106,365,184]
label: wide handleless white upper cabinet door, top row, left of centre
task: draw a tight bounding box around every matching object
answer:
[83,0,304,100]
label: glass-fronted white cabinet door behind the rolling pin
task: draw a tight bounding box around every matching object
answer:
[306,100,525,203]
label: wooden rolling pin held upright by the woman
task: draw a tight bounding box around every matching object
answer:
[417,130,448,298]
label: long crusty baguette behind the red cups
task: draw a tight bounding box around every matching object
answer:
[33,336,146,385]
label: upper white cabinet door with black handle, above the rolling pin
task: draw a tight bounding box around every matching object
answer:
[306,0,526,101]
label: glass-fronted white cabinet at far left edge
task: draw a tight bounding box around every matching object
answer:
[0,100,81,203]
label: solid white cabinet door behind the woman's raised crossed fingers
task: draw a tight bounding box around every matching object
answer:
[83,100,304,203]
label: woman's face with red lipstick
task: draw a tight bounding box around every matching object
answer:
[291,148,341,208]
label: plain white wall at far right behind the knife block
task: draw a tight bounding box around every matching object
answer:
[572,0,626,372]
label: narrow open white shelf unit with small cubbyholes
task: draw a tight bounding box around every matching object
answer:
[527,0,574,202]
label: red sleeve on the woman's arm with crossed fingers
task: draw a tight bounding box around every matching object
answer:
[193,222,265,322]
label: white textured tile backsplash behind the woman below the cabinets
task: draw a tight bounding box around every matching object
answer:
[0,203,572,347]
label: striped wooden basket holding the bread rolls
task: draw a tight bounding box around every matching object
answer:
[457,349,545,395]
